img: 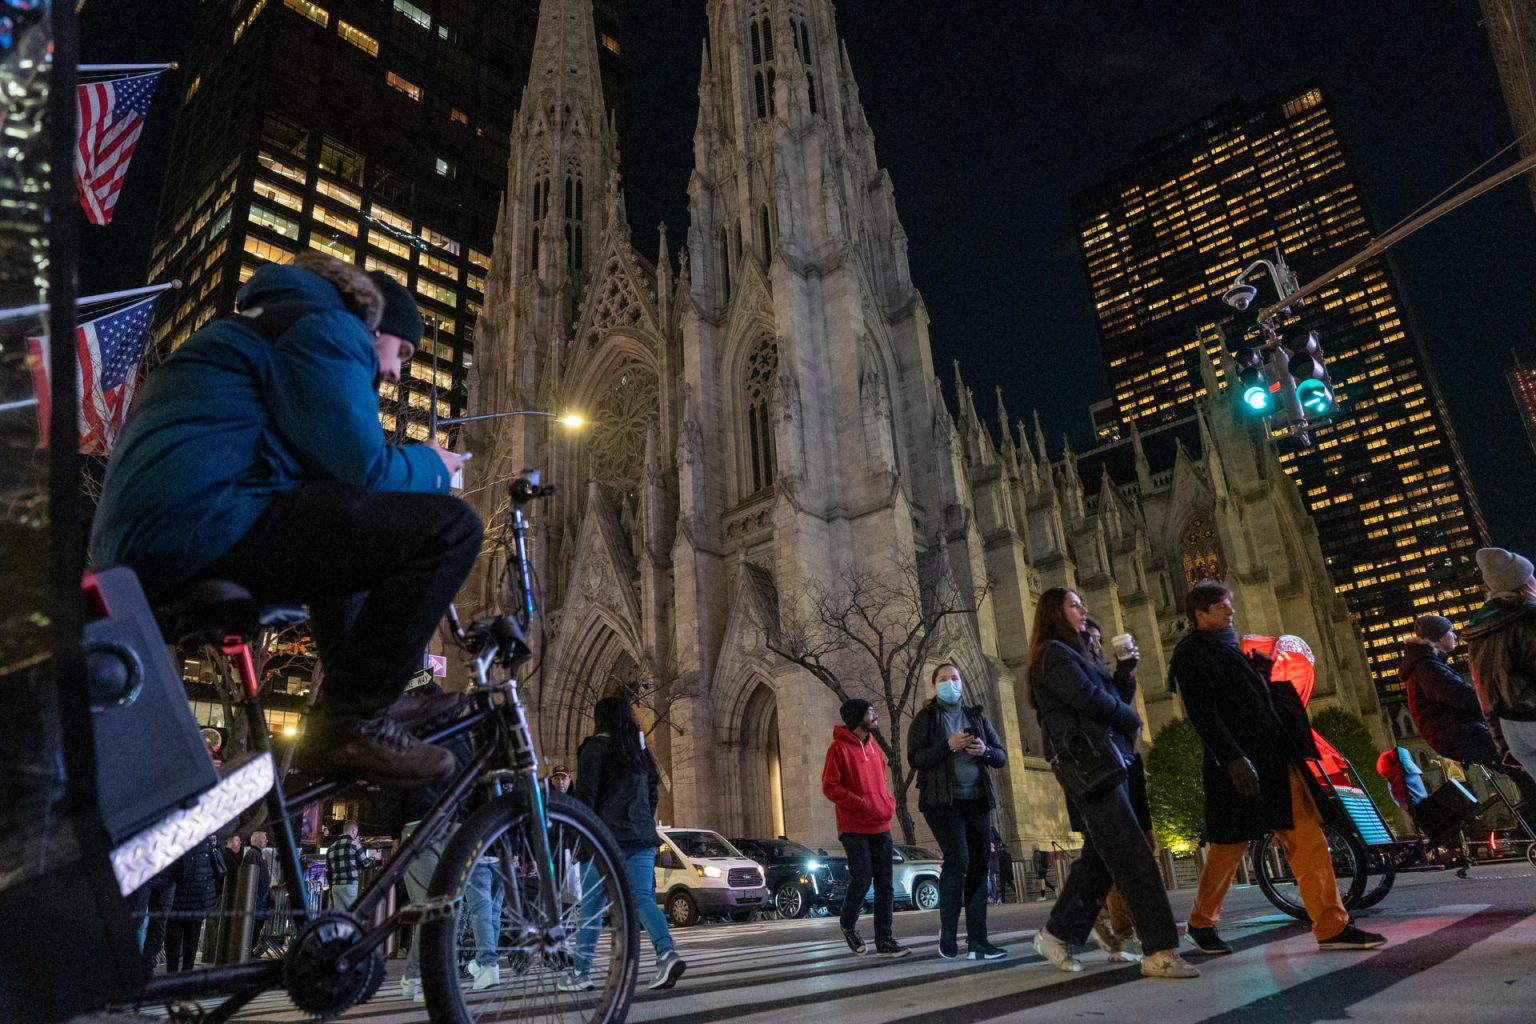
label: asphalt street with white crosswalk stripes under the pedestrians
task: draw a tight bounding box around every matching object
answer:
[108,861,1536,1024]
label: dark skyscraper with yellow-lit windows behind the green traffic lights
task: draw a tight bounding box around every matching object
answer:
[1072,84,1487,699]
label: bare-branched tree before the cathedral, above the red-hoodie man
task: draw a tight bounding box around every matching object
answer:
[759,553,991,844]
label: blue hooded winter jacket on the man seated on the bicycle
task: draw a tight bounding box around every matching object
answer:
[91,264,449,599]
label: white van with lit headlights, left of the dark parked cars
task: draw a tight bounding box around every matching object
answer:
[656,827,768,927]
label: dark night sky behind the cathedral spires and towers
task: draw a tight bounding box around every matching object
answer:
[83,0,1536,553]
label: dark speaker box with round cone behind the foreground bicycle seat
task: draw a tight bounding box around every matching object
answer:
[81,568,218,844]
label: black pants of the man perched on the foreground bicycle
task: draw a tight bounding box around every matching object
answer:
[200,481,481,722]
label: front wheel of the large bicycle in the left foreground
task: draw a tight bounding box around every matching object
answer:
[421,794,639,1024]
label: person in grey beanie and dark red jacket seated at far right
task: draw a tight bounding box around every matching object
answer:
[1398,607,1536,811]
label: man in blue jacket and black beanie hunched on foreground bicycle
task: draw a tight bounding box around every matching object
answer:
[91,252,481,786]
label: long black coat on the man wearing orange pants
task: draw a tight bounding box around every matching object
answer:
[1169,631,1318,843]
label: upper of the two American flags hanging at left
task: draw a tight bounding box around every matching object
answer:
[75,71,160,224]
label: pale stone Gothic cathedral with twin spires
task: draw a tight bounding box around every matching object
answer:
[465,0,1379,847]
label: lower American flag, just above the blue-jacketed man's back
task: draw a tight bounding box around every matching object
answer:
[26,298,155,457]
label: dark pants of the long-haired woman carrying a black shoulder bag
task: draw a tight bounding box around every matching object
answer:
[1046,783,1178,953]
